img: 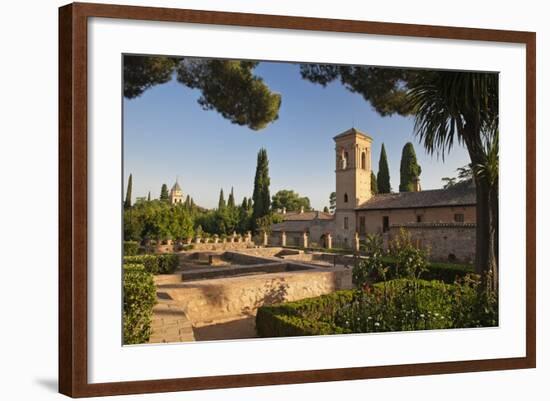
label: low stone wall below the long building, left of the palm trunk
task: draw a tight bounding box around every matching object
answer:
[384,223,476,263]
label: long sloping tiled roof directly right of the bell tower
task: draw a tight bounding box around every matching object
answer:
[356,183,476,210]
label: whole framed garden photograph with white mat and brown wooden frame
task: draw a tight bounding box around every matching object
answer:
[59,3,536,397]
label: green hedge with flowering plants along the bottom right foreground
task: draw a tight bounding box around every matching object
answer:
[256,279,498,337]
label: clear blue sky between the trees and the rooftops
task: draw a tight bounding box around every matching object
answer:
[123,62,469,209]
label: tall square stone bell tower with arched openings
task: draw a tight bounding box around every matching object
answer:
[334,128,372,246]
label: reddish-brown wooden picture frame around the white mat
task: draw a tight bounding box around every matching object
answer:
[59,3,536,397]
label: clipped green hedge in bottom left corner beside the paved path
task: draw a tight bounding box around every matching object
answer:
[123,264,157,344]
